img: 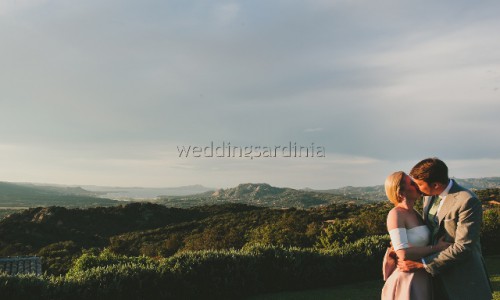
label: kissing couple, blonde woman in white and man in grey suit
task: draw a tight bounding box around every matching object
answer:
[382,158,493,300]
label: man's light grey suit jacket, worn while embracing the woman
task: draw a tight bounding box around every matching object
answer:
[423,181,492,300]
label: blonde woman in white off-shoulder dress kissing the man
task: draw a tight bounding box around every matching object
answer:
[382,171,450,300]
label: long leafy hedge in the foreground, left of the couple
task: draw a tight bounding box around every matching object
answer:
[0,236,389,300]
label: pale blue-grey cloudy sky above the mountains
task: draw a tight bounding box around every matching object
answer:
[0,0,500,189]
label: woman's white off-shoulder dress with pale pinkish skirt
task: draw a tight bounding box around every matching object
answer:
[382,225,432,300]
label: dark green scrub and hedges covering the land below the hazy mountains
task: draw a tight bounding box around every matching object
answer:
[0,179,500,299]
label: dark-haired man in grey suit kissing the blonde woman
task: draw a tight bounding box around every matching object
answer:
[398,158,492,300]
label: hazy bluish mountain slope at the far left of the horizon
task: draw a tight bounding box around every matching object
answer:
[0,182,119,208]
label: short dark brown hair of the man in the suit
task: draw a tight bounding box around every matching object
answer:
[410,157,450,184]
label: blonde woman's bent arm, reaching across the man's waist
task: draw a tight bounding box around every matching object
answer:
[387,209,450,260]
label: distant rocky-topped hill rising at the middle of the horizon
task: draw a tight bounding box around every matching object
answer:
[156,183,367,208]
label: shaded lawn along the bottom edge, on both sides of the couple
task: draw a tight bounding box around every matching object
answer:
[247,256,500,300]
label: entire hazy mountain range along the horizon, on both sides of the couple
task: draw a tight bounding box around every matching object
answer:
[0,177,500,208]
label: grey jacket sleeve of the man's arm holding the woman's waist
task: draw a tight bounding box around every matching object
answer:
[424,197,483,276]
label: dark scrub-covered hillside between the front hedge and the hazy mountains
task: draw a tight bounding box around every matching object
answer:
[0,202,387,274]
